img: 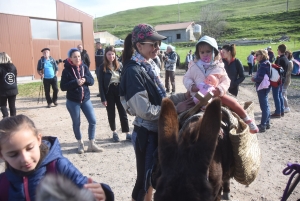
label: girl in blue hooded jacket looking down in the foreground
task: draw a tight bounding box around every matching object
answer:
[0,115,114,201]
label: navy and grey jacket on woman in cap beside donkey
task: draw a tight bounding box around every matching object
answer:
[119,60,162,132]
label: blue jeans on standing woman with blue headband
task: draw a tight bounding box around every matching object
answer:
[66,99,96,140]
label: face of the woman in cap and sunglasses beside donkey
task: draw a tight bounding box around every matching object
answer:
[137,40,159,60]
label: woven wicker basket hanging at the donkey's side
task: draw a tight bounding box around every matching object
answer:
[229,102,261,185]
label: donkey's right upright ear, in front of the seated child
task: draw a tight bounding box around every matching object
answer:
[195,98,221,171]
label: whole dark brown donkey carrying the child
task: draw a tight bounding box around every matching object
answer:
[154,99,233,201]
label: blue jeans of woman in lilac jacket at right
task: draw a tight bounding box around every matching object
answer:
[257,87,271,126]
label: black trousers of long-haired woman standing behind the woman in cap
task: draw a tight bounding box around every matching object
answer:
[105,83,129,133]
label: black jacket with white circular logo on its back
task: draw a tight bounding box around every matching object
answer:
[0,63,18,97]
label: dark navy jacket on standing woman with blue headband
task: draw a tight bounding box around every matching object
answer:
[60,60,94,103]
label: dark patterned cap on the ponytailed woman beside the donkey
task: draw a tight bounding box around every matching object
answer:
[131,24,167,43]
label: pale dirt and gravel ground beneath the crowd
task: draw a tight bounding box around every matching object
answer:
[0,75,300,201]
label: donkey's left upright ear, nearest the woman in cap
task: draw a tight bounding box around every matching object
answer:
[158,98,179,167]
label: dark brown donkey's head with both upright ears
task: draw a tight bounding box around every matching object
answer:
[154,98,221,201]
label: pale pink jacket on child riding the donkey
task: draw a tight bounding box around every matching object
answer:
[183,61,230,96]
